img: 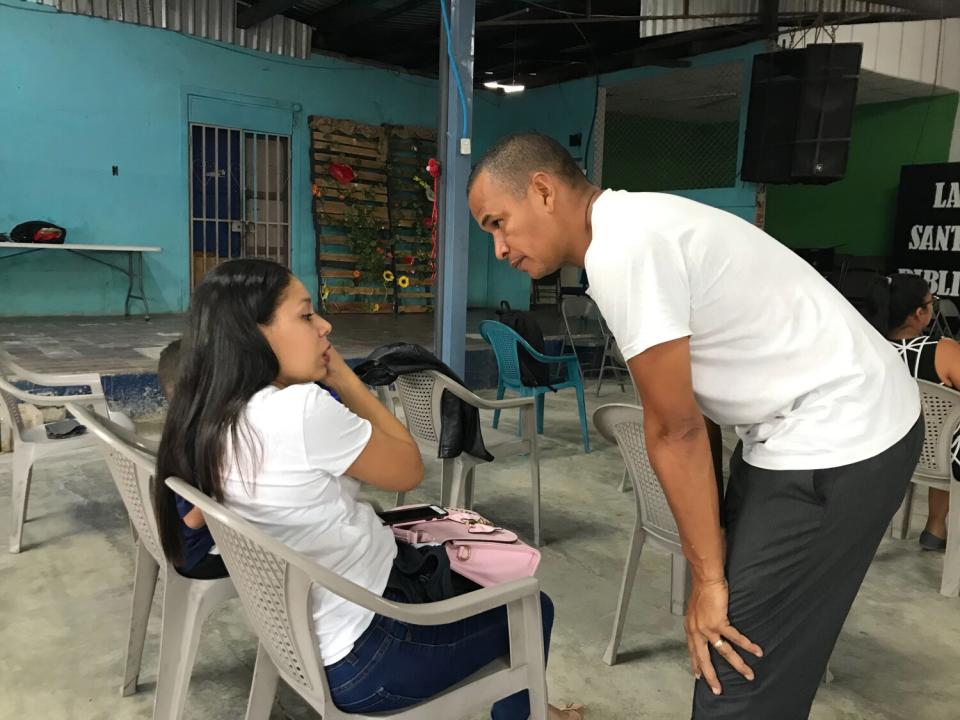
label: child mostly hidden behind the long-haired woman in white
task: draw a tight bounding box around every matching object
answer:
[157,340,229,580]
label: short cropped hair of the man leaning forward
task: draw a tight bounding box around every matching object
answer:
[467,132,587,197]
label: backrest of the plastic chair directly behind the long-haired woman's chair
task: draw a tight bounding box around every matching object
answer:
[67,403,167,567]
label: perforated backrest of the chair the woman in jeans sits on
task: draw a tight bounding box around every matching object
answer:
[167,478,344,716]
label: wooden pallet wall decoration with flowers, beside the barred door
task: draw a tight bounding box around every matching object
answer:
[310,116,436,313]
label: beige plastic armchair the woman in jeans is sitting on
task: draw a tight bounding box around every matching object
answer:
[166,478,547,720]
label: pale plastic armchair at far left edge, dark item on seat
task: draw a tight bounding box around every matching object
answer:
[0,353,133,553]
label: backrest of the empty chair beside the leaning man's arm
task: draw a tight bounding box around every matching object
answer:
[593,403,680,548]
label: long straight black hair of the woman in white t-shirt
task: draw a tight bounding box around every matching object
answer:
[153,260,292,565]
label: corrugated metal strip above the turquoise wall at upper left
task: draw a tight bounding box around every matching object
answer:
[36,0,313,59]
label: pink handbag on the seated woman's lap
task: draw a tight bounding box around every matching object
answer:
[393,508,540,587]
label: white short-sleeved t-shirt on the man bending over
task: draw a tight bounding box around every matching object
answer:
[585,190,920,470]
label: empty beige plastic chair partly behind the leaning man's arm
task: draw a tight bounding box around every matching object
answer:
[593,403,688,665]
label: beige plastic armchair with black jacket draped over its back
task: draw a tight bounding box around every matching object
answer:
[386,370,541,545]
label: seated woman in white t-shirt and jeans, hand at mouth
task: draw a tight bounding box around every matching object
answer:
[155,260,583,720]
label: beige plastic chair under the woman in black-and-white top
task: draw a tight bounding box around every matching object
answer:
[892,380,960,597]
